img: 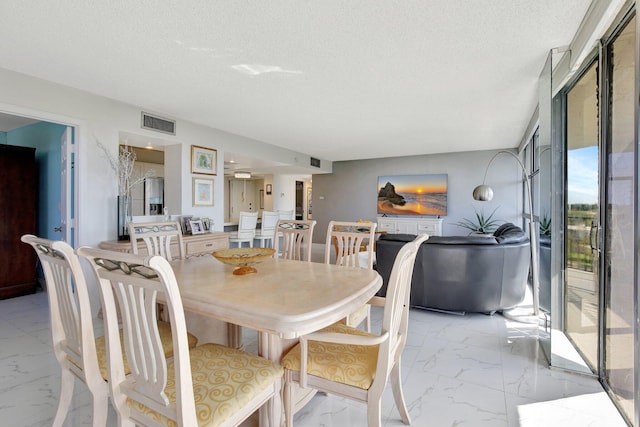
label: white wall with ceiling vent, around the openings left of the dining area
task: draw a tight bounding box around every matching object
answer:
[0,69,331,305]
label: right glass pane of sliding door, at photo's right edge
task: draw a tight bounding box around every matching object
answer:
[603,12,636,420]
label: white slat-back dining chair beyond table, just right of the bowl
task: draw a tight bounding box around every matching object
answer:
[274,219,316,262]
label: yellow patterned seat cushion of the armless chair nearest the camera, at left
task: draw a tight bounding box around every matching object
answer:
[127,344,283,427]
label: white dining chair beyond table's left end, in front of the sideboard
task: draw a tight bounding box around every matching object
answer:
[127,221,185,261]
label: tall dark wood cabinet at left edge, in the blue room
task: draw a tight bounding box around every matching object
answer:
[0,145,38,299]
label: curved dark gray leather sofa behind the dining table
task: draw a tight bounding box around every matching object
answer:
[376,223,530,314]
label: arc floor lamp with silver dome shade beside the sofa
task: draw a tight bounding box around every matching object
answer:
[473,150,540,323]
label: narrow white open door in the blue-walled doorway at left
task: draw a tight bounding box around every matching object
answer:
[56,127,76,247]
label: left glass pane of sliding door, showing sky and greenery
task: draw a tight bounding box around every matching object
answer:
[564,62,600,372]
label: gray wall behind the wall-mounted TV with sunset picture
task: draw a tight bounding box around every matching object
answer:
[313,150,523,243]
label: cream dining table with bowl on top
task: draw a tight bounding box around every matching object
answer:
[171,252,382,425]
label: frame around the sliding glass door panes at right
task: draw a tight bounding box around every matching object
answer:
[550,2,640,426]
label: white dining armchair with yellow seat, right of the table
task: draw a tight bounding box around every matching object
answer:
[282,234,428,427]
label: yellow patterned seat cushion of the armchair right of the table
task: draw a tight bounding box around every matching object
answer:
[282,323,378,390]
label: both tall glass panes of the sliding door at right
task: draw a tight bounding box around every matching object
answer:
[562,10,640,422]
